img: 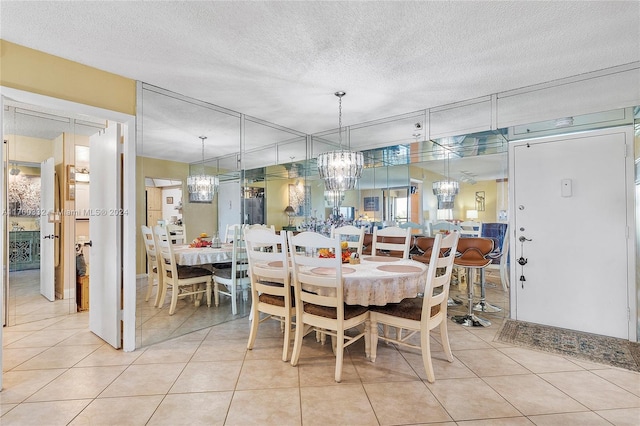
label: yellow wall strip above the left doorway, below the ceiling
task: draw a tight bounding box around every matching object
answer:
[0,40,136,115]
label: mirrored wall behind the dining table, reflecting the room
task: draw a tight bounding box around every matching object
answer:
[136,84,508,347]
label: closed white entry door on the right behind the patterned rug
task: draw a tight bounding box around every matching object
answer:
[510,129,633,339]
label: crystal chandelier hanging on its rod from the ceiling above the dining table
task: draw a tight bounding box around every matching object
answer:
[317,92,364,191]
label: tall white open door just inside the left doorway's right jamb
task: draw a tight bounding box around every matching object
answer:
[89,124,124,348]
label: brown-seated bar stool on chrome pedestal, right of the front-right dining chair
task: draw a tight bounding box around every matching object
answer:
[451,237,493,327]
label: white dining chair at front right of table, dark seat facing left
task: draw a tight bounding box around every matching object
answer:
[370,232,460,383]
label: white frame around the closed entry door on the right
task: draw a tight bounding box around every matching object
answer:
[509,126,638,342]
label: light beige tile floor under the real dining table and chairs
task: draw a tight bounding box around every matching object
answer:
[0,272,640,426]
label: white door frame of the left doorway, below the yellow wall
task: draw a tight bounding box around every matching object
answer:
[0,86,136,389]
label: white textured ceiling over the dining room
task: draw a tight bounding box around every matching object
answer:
[0,0,640,175]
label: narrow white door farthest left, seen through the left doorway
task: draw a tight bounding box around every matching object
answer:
[40,157,59,302]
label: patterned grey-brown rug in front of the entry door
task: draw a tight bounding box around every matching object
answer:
[496,320,640,371]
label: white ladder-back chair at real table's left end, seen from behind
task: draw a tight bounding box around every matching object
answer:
[244,229,295,361]
